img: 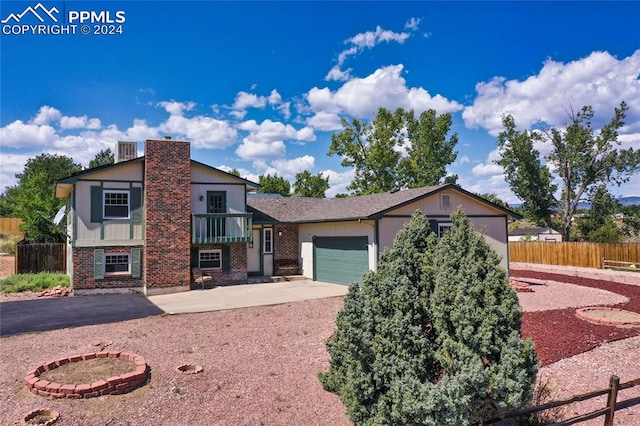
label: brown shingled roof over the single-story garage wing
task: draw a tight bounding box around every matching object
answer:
[247,184,520,223]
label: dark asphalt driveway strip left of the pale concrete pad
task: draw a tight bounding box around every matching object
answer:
[0,294,164,337]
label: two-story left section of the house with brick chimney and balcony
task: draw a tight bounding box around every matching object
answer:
[56,137,259,295]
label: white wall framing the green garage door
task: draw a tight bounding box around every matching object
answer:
[298,220,378,279]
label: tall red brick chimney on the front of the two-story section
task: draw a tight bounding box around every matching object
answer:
[143,137,191,295]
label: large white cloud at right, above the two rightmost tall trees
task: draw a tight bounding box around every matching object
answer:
[462,50,640,136]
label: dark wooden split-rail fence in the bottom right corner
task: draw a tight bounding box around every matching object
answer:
[484,376,640,426]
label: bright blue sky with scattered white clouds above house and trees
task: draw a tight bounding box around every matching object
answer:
[0,0,640,202]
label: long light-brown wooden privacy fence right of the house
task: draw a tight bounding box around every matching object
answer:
[509,241,640,268]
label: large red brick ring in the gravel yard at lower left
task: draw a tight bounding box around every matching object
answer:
[24,352,149,399]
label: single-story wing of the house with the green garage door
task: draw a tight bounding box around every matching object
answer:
[247,185,520,284]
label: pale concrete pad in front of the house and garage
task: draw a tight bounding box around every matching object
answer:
[148,280,349,314]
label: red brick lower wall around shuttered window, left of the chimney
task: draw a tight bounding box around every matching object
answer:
[72,246,144,290]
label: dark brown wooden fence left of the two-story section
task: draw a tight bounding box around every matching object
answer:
[16,243,67,274]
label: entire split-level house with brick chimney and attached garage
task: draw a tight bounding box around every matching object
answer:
[56,137,519,295]
